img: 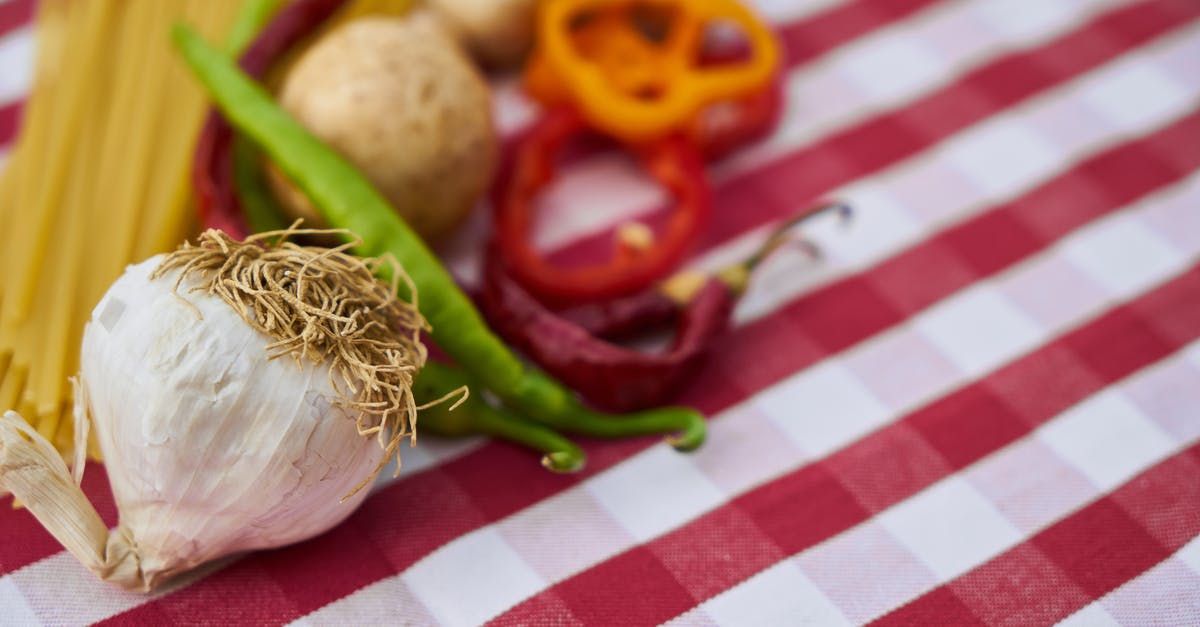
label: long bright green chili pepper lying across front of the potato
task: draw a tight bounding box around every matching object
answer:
[173,25,706,450]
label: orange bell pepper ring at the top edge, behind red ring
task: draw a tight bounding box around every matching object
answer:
[526,0,780,143]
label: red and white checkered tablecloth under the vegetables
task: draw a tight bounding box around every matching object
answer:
[0,0,1200,626]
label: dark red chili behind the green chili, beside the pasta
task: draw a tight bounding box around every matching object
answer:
[192,0,346,238]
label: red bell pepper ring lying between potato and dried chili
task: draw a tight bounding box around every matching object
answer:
[494,108,712,303]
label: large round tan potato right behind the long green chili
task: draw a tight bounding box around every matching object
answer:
[269,17,499,241]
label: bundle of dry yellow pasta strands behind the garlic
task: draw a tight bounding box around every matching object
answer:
[0,0,240,455]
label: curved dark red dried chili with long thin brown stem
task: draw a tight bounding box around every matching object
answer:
[479,203,848,411]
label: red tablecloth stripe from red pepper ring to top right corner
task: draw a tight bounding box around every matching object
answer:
[552,0,1200,264]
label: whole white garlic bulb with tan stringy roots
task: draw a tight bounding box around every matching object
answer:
[0,227,425,591]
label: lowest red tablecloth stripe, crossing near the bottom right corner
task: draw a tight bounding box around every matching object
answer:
[875,443,1200,626]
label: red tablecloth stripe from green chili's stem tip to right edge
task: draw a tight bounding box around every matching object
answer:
[689,106,1200,420]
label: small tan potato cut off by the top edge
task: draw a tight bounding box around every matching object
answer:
[427,0,538,68]
